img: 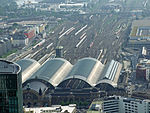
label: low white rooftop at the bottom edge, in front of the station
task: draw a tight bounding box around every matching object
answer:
[24,104,76,113]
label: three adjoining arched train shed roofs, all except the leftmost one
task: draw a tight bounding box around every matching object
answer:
[22,58,122,89]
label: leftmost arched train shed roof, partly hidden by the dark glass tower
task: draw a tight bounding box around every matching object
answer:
[16,59,41,83]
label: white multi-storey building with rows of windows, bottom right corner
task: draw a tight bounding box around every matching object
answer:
[87,96,150,113]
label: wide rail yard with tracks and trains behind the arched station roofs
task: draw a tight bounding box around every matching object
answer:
[5,13,129,64]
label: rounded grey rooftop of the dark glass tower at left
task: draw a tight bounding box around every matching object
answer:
[0,60,20,74]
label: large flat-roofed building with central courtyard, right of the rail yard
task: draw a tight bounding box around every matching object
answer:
[129,20,150,48]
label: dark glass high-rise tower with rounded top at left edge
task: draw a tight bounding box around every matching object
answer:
[0,60,23,113]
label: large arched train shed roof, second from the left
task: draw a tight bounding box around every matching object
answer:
[30,58,72,86]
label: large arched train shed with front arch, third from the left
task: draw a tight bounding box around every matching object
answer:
[58,58,104,88]
